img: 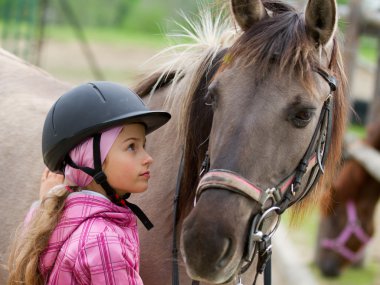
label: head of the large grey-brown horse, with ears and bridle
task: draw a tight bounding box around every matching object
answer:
[181,0,344,284]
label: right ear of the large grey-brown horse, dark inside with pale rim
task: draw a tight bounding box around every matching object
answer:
[305,0,338,45]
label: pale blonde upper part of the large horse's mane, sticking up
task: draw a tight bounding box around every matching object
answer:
[135,3,240,135]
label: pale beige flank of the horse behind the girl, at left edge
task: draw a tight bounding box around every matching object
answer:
[0,49,70,284]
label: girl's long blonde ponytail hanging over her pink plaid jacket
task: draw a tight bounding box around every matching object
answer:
[7,185,70,285]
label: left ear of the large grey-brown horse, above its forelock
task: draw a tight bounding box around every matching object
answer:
[231,0,268,31]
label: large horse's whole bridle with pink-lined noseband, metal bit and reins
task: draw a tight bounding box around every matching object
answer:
[172,50,337,285]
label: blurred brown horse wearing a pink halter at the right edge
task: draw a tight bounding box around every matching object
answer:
[315,121,380,277]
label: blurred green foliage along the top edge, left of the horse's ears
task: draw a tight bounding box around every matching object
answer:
[0,0,217,33]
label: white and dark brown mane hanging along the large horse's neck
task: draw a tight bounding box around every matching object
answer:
[134,4,240,220]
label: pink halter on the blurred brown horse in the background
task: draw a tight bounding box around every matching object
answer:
[321,200,371,263]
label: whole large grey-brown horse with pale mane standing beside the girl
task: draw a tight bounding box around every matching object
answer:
[0,0,346,285]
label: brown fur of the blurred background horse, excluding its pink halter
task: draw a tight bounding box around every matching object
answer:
[316,121,380,276]
